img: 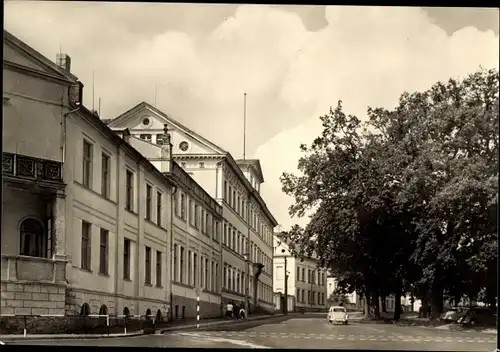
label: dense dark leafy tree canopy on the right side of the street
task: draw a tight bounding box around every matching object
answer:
[281,69,499,318]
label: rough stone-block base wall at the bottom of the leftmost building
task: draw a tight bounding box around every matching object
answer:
[0,282,66,315]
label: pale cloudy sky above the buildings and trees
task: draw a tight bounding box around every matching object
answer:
[4,1,499,228]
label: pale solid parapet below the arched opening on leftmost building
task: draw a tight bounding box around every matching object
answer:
[1,255,66,283]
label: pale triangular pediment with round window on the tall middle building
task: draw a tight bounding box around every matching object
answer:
[108,102,226,155]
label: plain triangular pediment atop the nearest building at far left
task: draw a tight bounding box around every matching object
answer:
[3,30,78,81]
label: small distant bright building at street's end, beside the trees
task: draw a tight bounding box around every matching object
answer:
[273,236,327,311]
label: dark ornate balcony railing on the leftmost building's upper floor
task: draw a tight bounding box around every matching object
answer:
[2,153,62,182]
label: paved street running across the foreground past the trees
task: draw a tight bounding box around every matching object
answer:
[3,318,496,352]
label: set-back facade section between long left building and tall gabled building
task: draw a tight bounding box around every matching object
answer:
[129,130,222,319]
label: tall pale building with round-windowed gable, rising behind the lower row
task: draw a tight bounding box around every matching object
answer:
[103,102,277,311]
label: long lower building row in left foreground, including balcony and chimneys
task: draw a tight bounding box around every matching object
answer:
[1,31,222,324]
